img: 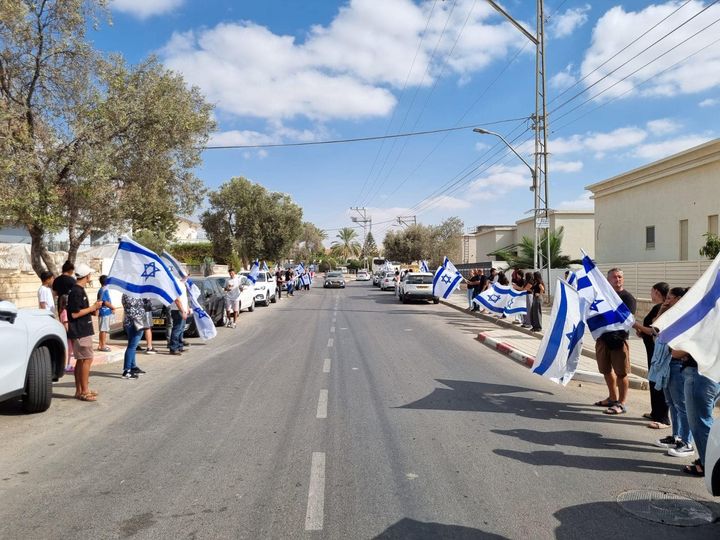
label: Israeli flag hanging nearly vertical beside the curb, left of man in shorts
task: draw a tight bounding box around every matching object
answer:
[532,279,585,386]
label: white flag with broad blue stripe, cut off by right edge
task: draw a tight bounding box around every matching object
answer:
[653,255,720,381]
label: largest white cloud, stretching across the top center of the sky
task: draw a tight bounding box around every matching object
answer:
[161,0,523,121]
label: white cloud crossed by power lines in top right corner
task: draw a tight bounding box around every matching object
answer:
[581,0,720,99]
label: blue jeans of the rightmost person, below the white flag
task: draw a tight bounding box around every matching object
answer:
[683,367,720,466]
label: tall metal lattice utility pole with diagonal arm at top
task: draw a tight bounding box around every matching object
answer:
[486,0,551,287]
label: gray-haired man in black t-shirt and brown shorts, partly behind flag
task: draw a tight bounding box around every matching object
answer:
[595,268,637,415]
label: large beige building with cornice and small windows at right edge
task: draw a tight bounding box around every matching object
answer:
[584,139,720,263]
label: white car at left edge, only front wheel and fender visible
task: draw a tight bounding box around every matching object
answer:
[0,301,67,413]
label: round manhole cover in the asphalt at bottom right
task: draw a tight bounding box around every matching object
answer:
[617,489,713,527]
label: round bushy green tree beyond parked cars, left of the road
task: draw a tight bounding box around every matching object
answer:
[201,177,302,263]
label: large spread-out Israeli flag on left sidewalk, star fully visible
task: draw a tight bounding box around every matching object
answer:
[107,236,182,306]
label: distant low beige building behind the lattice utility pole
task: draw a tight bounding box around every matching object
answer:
[461,210,595,263]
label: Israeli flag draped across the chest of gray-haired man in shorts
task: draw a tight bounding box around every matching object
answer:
[577,252,635,339]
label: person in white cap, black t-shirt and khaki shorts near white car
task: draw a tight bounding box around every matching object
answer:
[67,263,102,401]
